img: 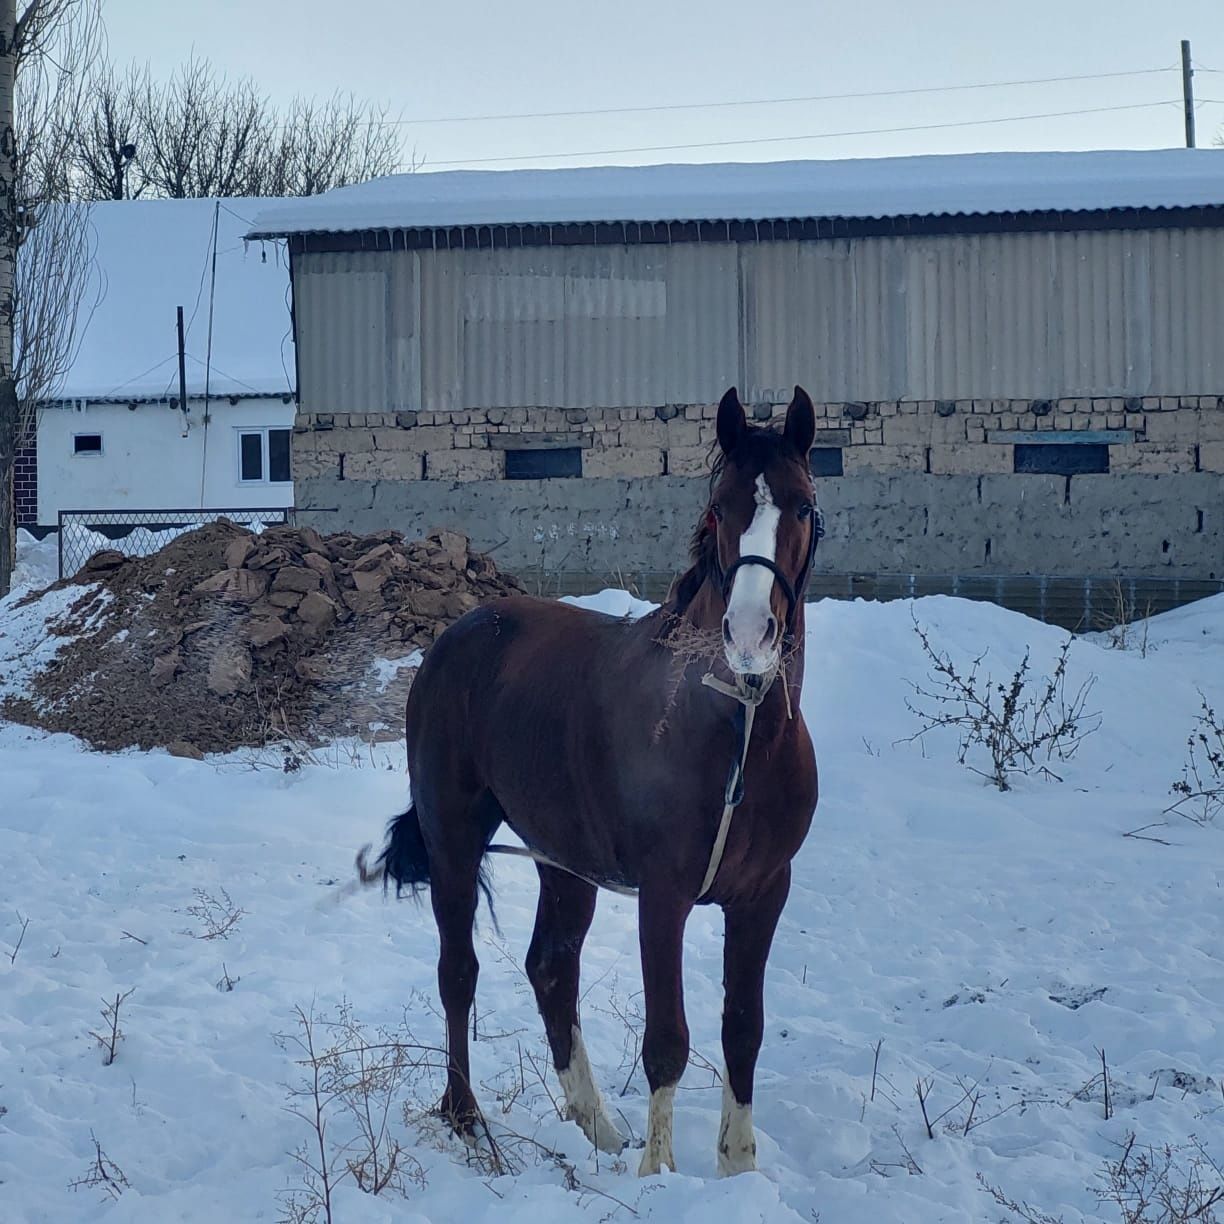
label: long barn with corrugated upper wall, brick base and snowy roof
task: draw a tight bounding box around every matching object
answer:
[256,151,1224,619]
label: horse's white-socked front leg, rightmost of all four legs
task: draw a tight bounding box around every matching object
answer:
[718,864,791,1177]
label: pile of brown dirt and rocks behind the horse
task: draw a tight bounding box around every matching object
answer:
[0,519,521,755]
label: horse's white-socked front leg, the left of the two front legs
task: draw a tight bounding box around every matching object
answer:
[638,885,693,1177]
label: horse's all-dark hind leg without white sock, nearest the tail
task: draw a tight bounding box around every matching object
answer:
[426,797,497,1138]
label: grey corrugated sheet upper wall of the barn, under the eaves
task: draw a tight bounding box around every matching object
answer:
[294,229,1224,412]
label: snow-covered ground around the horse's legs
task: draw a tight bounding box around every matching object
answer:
[0,560,1224,1224]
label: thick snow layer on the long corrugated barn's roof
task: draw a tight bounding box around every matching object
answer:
[243,149,1224,237]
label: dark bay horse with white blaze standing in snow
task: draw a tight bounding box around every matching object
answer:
[359,387,821,1176]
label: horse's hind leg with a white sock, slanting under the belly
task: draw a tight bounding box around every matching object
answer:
[528,865,624,1155]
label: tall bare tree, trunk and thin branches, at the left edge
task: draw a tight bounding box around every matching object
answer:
[0,0,102,595]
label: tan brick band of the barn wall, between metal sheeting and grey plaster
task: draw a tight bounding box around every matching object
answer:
[294,395,1224,482]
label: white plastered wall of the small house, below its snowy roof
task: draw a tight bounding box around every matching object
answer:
[38,398,295,526]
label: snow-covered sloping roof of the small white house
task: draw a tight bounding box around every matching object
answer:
[48,198,294,400]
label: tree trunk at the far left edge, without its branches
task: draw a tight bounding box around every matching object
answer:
[0,0,20,595]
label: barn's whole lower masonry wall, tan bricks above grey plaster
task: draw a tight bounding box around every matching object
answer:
[294,397,1224,597]
